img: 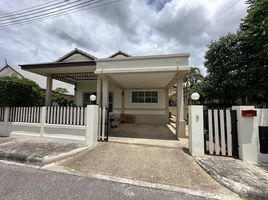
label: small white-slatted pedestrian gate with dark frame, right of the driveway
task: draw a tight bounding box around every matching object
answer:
[204,109,238,158]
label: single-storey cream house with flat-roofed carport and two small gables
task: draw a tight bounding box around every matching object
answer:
[20,49,190,136]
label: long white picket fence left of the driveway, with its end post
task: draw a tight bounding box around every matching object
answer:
[0,105,101,145]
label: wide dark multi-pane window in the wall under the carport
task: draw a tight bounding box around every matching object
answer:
[132,91,158,103]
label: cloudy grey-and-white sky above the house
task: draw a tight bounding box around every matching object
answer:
[0,0,247,74]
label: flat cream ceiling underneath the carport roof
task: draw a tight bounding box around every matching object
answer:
[109,72,176,88]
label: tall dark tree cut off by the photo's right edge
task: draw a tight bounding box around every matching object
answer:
[240,0,268,105]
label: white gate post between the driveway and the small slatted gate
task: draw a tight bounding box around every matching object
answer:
[188,105,205,156]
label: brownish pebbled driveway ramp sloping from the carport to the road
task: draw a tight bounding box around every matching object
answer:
[52,142,237,196]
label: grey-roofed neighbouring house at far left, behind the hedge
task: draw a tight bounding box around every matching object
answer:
[0,63,74,95]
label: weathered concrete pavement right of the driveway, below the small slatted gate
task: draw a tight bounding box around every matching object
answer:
[196,156,268,199]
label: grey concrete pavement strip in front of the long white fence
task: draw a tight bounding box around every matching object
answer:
[0,136,86,165]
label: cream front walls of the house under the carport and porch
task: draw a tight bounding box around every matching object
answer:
[75,80,167,124]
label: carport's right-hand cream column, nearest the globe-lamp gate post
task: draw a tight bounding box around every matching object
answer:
[176,77,185,138]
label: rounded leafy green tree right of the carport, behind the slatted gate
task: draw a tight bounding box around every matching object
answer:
[204,32,248,104]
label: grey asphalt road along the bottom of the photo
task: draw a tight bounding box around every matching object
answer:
[0,163,217,200]
